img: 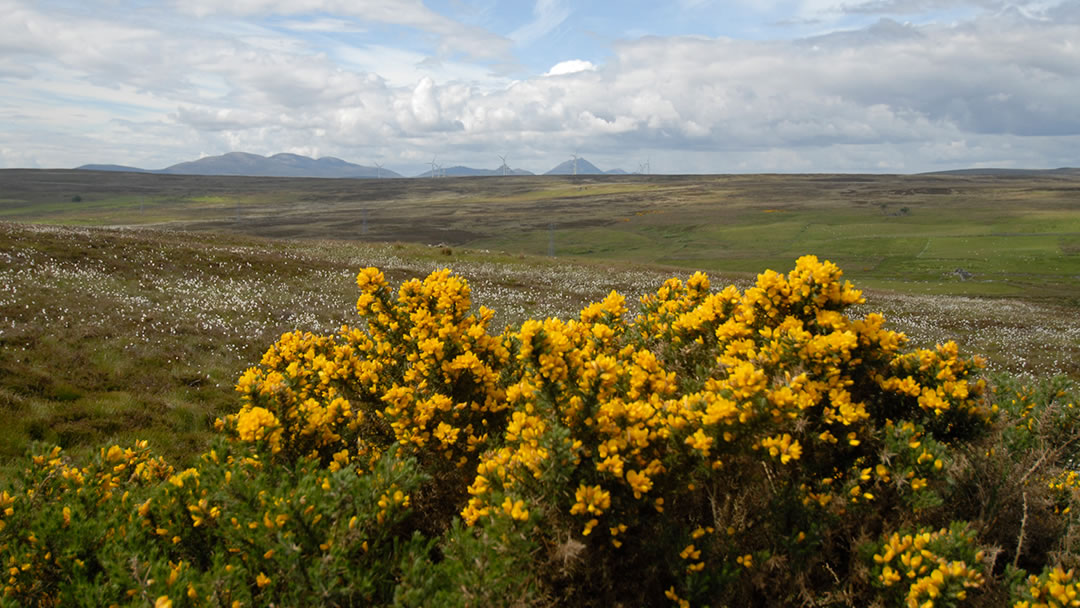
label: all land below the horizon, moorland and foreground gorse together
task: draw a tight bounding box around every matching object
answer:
[0,171,1080,606]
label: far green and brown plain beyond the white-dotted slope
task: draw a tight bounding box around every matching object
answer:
[0,171,1080,305]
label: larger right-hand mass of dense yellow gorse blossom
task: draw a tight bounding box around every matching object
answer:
[462,256,988,548]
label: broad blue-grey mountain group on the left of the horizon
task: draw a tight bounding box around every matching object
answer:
[76,152,402,177]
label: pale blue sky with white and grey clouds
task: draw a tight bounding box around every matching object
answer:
[0,0,1080,175]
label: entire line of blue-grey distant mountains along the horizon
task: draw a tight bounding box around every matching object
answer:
[76,152,626,177]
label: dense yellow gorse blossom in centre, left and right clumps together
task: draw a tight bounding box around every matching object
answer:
[214,256,989,596]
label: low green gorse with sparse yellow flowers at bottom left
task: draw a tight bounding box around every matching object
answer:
[0,442,428,607]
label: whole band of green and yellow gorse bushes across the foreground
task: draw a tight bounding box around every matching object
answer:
[0,256,1080,607]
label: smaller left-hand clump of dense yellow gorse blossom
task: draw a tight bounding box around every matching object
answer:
[221,268,509,475]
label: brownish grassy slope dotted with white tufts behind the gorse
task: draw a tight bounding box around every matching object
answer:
[0,219,1080,471]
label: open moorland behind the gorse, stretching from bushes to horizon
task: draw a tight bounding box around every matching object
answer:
[0,170,1080,466]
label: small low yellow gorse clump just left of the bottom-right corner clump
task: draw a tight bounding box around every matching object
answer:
[874,529,985,608]
